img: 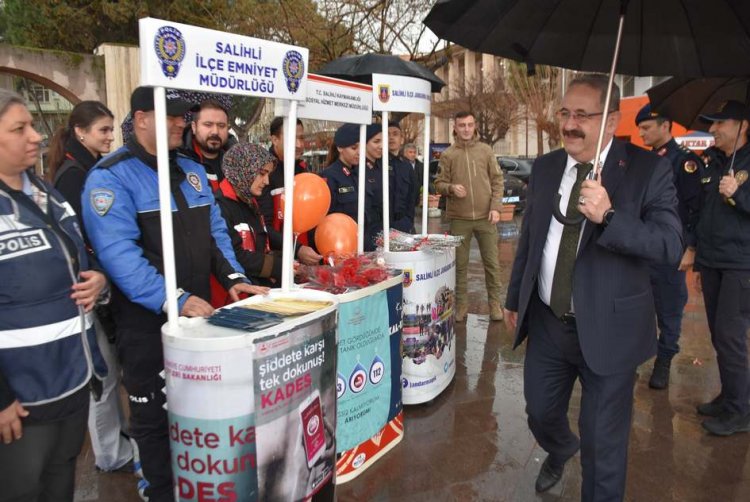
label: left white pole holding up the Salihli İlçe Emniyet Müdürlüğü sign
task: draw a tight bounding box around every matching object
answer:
[154,87,179,334]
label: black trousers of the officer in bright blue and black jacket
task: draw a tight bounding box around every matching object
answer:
[117,333,174,502]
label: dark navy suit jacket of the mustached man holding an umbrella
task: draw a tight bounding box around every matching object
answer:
[506,140,683,375]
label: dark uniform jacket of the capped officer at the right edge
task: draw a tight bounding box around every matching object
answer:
[695,143,750,270]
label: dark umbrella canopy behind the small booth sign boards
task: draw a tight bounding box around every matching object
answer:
[318,54,445,92]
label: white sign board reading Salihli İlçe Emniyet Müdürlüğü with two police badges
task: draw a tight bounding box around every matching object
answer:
[139,18,309,100]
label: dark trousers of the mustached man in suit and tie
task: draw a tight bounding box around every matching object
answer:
[524,295,635,502]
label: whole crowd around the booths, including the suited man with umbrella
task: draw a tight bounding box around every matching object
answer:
[0,75,750,501]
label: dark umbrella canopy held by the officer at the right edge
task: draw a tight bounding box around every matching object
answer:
[646,76,750,131]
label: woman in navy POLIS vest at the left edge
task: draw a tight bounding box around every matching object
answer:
[0,89,107,501]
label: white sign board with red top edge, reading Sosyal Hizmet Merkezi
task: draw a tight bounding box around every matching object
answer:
[274,74,372,124]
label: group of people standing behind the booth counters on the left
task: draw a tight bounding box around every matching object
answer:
[0,87,428,501]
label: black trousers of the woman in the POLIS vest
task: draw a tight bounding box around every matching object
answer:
[0,401,89,502]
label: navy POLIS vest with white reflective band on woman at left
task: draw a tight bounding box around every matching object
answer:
[0,172,107,409]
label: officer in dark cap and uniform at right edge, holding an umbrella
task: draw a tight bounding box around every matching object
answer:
[695,101,750,436]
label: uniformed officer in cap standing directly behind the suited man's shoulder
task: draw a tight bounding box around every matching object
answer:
[635,104,703,389]
